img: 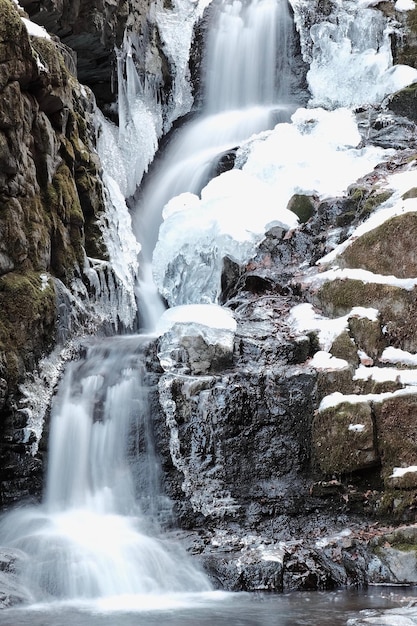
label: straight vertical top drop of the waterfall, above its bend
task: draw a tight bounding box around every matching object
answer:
[202,0,293,114]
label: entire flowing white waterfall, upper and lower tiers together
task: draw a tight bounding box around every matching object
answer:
[0,0,300,601]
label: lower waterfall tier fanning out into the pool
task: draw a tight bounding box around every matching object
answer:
[0,337,210,601]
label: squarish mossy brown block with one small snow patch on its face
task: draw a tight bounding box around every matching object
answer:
[312,402,378,476]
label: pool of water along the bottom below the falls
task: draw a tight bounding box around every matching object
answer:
[0,587,417,626]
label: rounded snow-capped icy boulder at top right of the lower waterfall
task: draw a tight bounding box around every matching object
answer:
[156,304,236,375]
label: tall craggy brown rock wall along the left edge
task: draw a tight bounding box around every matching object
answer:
[0,0,111,501]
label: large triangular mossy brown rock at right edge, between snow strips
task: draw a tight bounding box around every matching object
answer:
[338,213,417,278]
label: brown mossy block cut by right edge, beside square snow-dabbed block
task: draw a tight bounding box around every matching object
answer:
[375,394,417,489]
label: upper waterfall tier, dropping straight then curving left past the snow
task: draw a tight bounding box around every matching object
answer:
[135,0,295,328]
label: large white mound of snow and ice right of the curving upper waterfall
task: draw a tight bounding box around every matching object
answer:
[153,109,391,306]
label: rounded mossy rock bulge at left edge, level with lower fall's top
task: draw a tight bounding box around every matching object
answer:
[0,272,56,387]
